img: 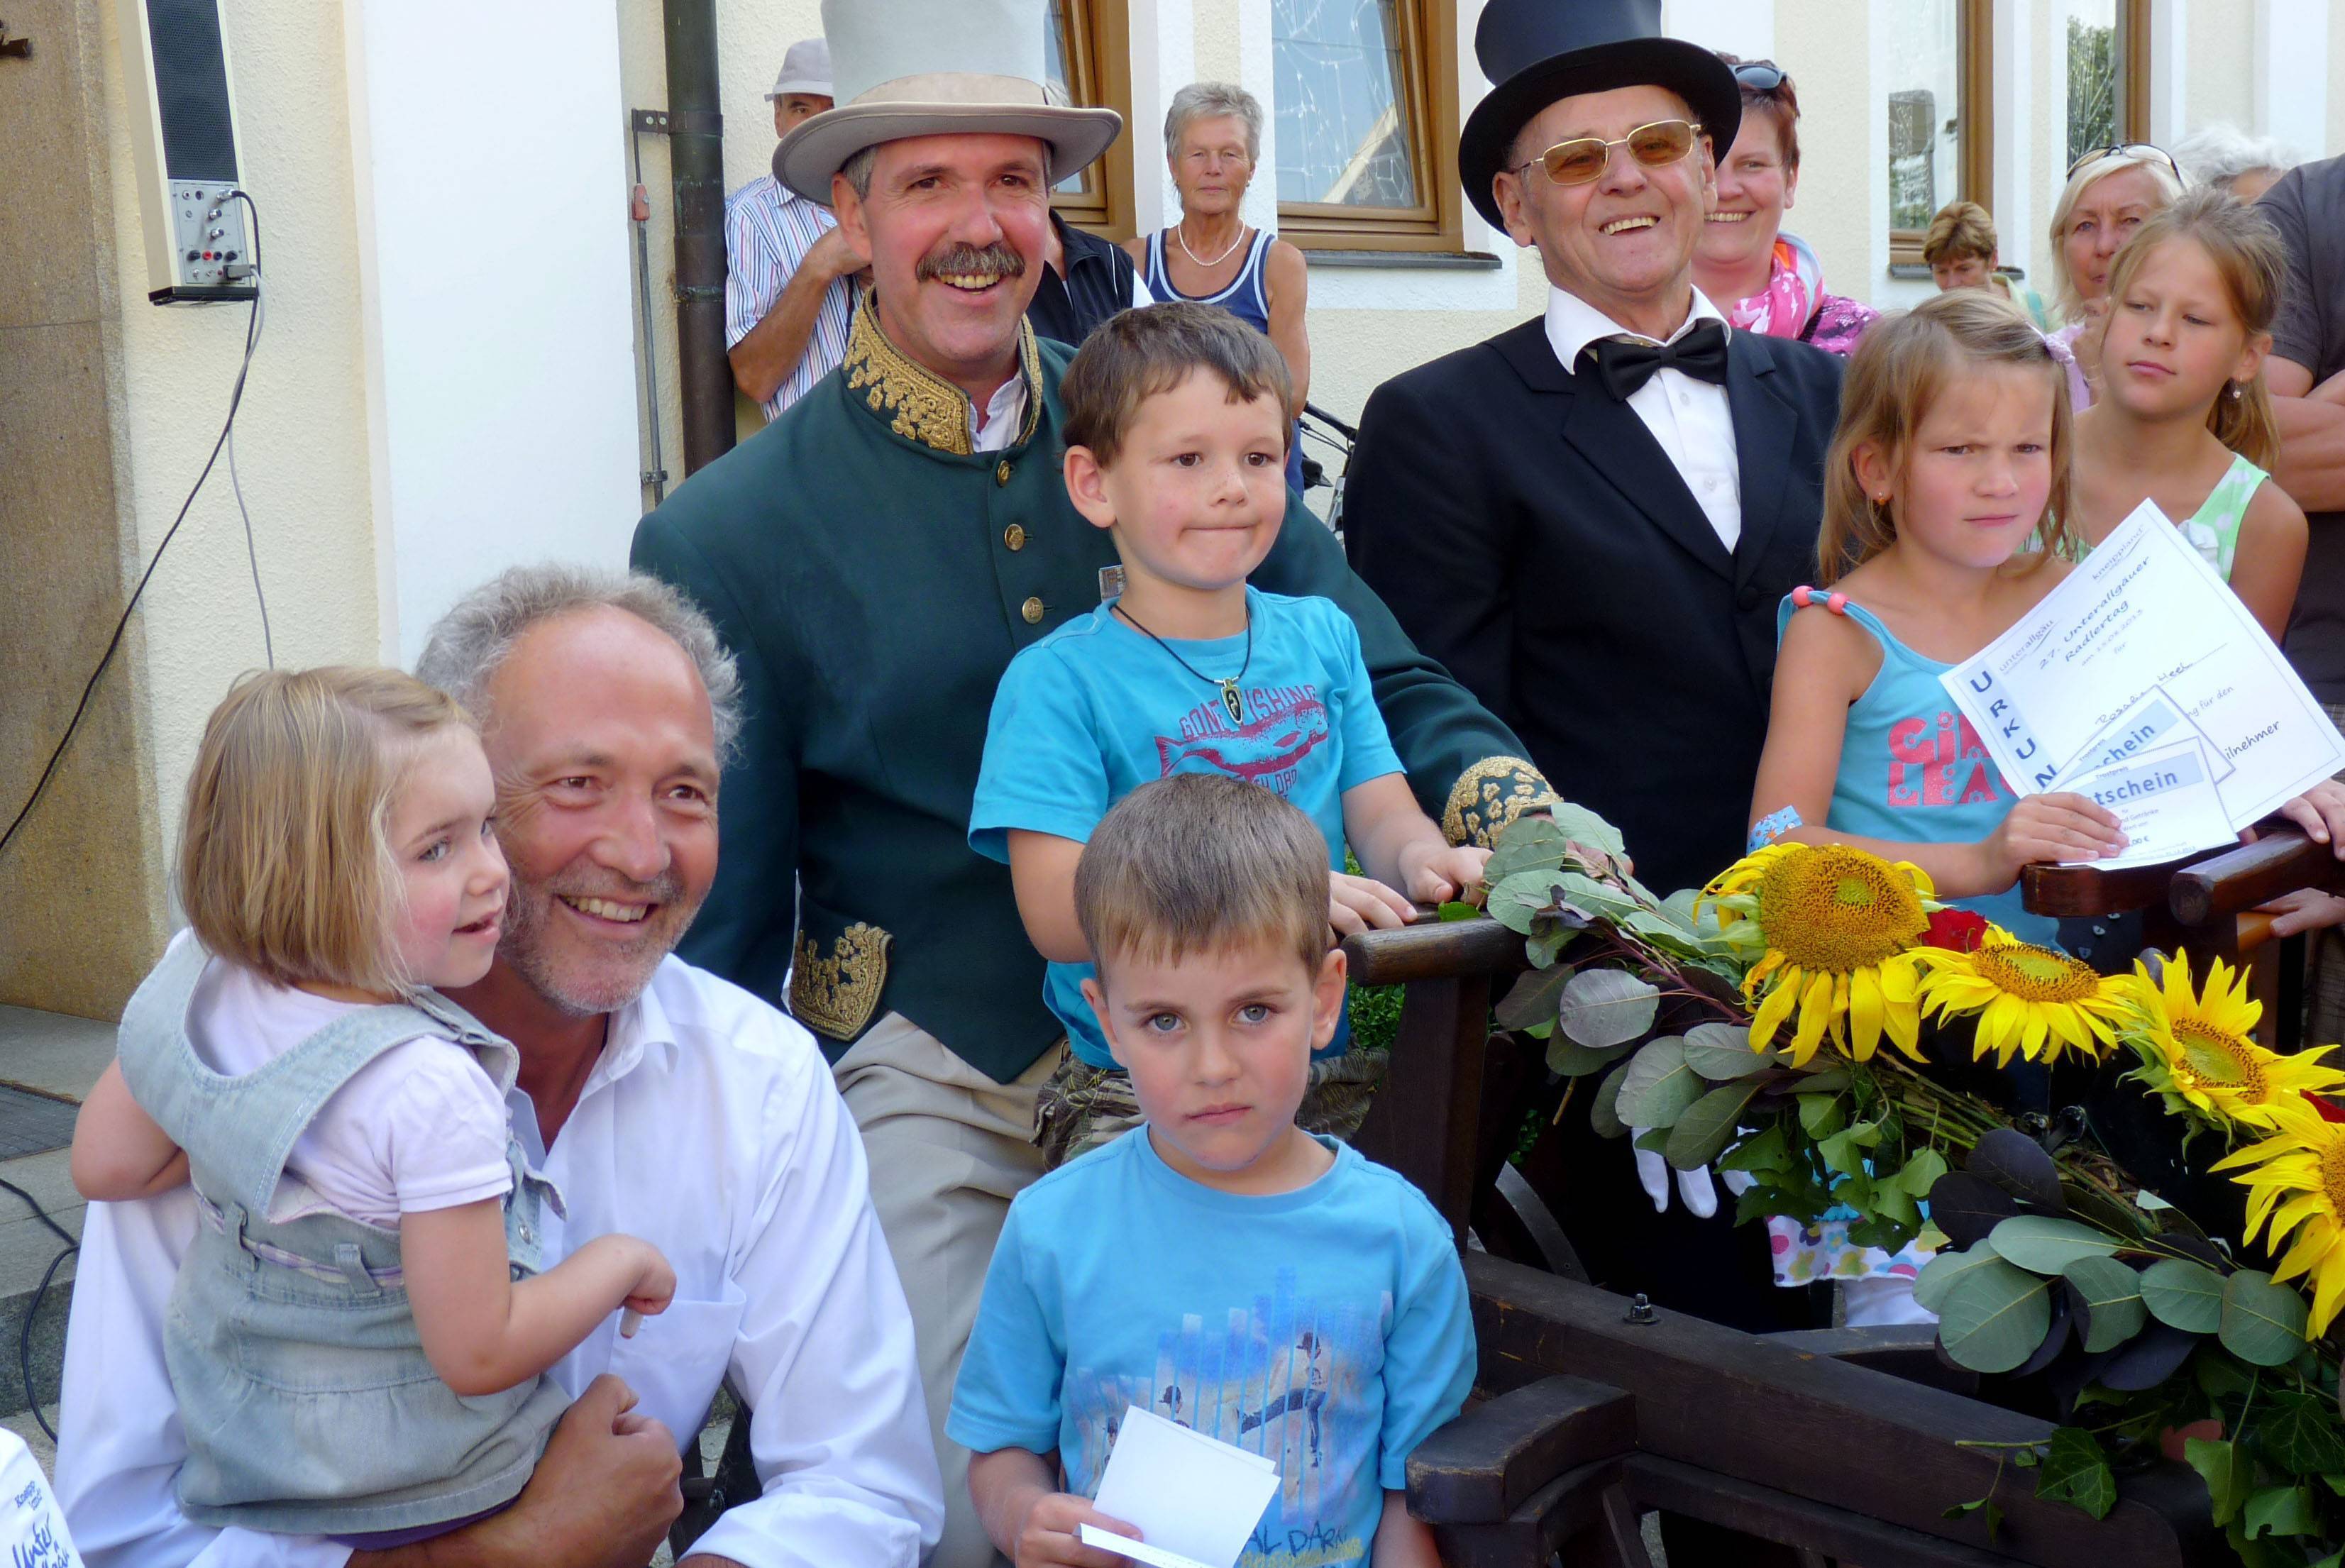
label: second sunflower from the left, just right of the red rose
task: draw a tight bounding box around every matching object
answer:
[1921,926,2131,1066]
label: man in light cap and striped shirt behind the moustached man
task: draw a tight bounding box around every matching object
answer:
[724,38,863,419]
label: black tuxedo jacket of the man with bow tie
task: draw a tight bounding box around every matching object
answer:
[1344,319,1841,893]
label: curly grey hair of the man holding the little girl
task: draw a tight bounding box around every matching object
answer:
[415,563,741,762]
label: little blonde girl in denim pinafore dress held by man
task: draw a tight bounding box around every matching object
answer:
[72,668,675,1550]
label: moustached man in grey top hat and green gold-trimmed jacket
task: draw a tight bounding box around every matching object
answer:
[633,0,1547,1568]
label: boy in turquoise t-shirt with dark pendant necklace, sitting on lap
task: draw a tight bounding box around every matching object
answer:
[969,302,1489,1165]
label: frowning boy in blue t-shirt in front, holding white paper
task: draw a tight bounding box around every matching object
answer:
[945,775,1475,1568]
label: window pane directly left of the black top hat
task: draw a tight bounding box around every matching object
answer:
[1271,0,1419,206]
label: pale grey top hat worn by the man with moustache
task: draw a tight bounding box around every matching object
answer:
[774,0,1123,206]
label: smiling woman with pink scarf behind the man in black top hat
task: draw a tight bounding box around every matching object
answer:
[1693,49,1881,356]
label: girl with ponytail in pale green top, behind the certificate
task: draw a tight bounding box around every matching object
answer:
[2075,187,2305,642]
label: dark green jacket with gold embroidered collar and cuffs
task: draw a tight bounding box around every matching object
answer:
[633,307,1547,1083]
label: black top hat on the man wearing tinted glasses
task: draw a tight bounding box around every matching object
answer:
[1459,0,1743,227]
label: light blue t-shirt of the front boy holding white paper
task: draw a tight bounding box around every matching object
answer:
[945,1127,1475,1568]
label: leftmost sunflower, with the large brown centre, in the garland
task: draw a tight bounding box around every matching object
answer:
[1705,844,1932,1066]
